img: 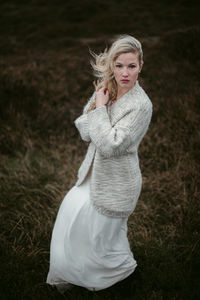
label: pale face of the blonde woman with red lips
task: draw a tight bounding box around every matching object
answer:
[114,52,142,91]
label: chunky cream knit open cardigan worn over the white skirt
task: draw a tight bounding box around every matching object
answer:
[75,81,152,217]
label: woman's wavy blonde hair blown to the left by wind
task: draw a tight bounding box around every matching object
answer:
[88,35,143,111]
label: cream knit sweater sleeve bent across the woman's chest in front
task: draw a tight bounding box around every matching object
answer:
[87,103,152,157]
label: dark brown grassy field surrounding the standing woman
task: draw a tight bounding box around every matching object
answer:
[0,0,200,300]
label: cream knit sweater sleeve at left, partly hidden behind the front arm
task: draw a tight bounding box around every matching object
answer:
[74,92,95,142]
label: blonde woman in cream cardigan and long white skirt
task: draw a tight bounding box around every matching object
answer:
[47,35,152,291]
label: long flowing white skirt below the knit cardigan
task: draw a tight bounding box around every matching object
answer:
[47,172,137,291]
